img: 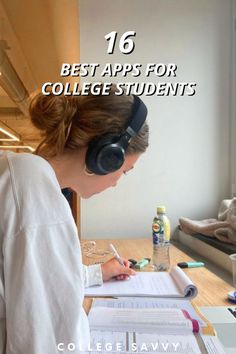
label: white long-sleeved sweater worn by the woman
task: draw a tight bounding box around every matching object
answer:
[0,152,102,354]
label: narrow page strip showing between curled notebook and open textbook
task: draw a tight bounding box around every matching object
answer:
[92,297,206,327]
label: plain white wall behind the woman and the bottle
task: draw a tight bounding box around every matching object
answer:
[79,0,231,238]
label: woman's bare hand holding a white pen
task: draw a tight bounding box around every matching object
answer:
[101,258,136,281]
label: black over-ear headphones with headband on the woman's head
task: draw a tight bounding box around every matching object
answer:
[85,95,147,175]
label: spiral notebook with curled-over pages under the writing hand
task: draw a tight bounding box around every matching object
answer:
[85,267,197,299]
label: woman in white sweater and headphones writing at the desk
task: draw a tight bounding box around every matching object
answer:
[0,87,148,354]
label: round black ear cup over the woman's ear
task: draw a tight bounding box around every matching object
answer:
[85,134,125,175]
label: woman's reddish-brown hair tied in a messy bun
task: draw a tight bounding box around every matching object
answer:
[29,85,149,158]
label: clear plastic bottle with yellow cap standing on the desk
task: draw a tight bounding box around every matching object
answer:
[152,206,170,271]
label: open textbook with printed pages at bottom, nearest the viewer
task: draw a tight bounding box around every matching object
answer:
[85,299,224,354]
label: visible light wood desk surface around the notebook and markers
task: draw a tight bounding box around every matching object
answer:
[81,239,232,308]
